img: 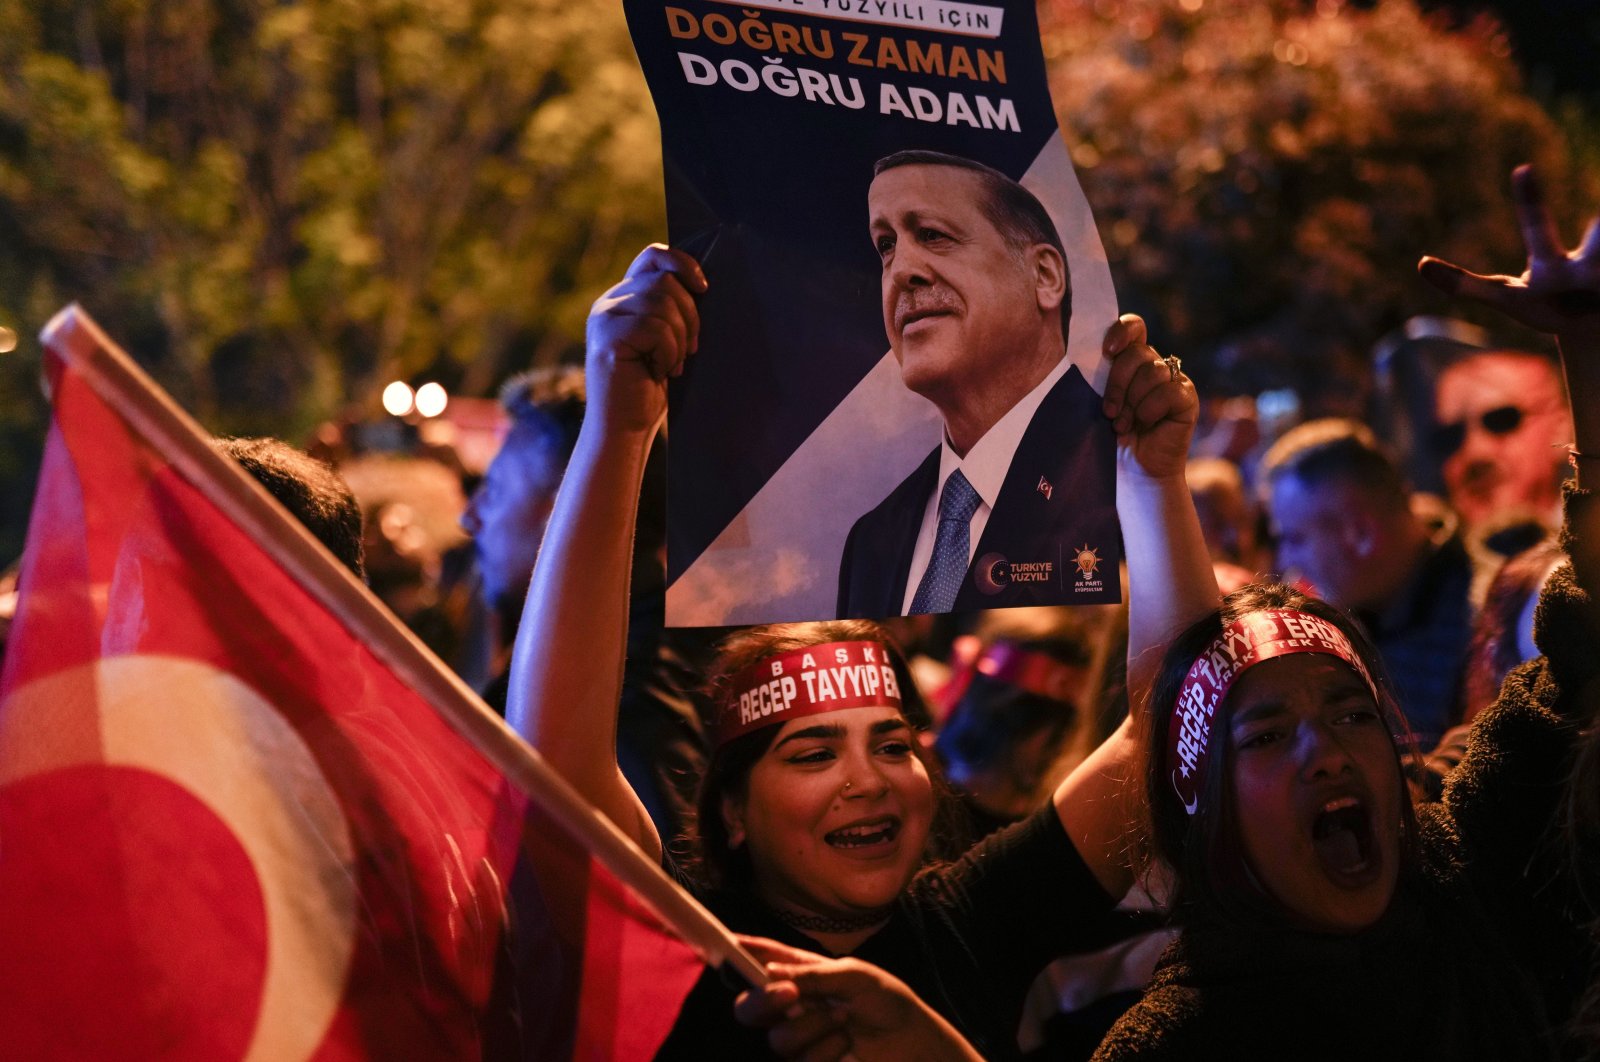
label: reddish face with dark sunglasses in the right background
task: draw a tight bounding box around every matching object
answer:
[1430,350,1573,537]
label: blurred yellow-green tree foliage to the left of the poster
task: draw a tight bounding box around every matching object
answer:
[0,0,662,559]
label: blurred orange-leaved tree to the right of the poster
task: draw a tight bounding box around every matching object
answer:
[1040,0,1597,413]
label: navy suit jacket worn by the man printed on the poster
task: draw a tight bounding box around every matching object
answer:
[838,365,1122,619]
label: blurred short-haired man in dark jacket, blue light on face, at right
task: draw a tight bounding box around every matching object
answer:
[1262,419,1472,749]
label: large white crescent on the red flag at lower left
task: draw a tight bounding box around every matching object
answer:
[0,656,357,1062]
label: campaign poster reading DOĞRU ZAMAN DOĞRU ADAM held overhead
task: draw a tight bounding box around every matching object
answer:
[626,0,1122,627]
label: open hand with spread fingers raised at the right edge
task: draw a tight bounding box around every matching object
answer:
[1418,166,1600,344]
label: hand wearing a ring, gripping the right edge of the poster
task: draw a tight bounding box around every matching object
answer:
[1102,313,1200,480]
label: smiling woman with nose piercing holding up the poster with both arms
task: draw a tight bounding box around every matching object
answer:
[507,246,1218,1059]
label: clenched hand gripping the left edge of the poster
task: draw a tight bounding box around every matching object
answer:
[586,243,706,432]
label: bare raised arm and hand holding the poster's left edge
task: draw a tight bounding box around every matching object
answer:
[506,245,706,856]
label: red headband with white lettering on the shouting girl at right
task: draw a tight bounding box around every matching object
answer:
[1166,608,1378,814]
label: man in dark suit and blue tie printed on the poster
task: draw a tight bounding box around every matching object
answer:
[838,150,1115,617]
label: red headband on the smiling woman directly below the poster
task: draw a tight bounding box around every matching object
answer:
[712,641,901,745]
